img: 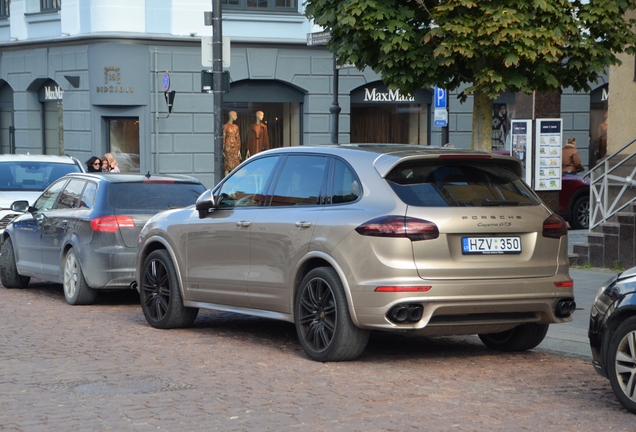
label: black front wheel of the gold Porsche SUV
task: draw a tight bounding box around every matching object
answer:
[139,249,199,329]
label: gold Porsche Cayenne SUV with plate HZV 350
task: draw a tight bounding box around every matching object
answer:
[136,144,576,361]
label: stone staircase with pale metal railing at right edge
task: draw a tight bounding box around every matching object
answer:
[569,138,636,269]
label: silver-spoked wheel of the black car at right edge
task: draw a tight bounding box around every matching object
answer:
[606,317,636,414]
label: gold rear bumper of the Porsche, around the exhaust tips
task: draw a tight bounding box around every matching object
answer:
[351,275,574,336]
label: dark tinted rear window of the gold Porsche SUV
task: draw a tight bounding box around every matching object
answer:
[386,163,541,207]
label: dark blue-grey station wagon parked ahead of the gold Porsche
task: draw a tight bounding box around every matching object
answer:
[0,173,205,304]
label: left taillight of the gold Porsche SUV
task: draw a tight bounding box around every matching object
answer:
[356,216,439,241]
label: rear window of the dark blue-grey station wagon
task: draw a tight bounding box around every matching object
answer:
[108,183,205,210]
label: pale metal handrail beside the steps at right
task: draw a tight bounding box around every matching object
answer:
[585,138,636,230]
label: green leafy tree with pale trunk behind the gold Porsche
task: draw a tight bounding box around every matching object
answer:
[305,0,636,151]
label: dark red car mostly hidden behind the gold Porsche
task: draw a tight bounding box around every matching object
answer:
[493,150,590,229]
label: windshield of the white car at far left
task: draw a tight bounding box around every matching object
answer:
[0,161,80,192]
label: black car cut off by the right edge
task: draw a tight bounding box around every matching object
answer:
[588,267,636,414]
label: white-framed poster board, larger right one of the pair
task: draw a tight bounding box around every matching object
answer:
[534,119,563,191]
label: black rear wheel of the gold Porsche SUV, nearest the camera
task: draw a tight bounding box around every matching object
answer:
[294,267,369,362]
